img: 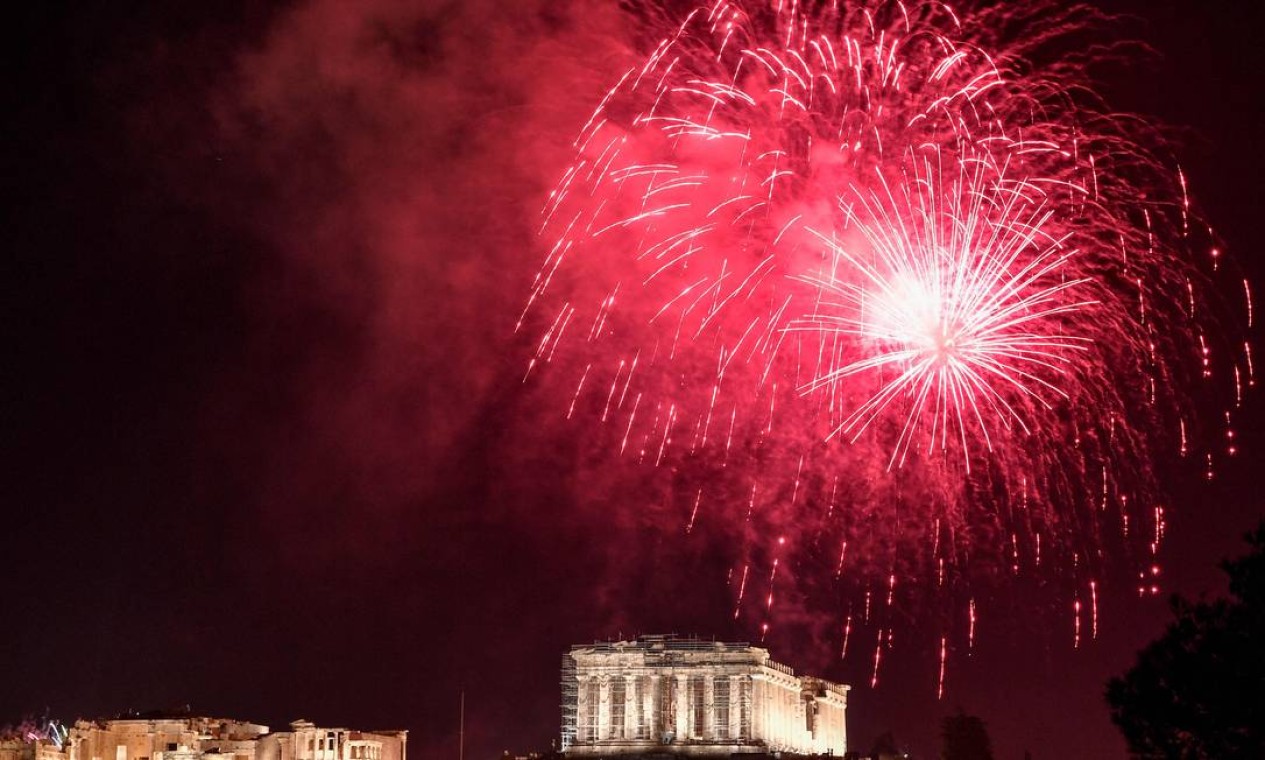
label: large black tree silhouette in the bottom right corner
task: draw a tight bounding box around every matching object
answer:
[1107,522,1265,760]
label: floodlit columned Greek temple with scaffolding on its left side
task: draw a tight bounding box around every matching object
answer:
[562,636,849,755]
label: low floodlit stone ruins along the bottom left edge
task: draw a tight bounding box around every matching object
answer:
[0,717,409,760]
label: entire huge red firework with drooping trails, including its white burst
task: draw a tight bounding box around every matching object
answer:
[519,0,1254,679]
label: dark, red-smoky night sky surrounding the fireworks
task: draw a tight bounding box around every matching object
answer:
[9,0,1265,760]
